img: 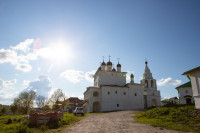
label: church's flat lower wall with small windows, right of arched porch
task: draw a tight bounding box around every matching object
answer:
[102,86,144,111]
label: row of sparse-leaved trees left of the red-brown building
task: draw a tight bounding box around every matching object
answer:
[9,89,68,114]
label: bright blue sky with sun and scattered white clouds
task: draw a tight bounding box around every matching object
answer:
[0,0,200,104]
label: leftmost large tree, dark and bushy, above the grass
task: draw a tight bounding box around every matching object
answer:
[12,91,36,114]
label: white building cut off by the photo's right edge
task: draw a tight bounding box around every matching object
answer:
[183,66,200,109]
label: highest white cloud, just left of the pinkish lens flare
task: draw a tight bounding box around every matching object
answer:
[10,39,34,52]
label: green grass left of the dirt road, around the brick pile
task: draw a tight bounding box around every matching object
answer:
[0,113,83,133]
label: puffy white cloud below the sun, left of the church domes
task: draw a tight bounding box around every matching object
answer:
[60,69,84,83]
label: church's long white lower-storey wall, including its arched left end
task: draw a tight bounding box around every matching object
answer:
[85,84,144,112]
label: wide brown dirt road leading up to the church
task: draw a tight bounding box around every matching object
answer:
[63,111,183,133]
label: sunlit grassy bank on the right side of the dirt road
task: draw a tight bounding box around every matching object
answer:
[134,106,200,132]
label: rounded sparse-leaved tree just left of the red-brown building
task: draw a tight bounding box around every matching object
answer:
[49,89,68,109]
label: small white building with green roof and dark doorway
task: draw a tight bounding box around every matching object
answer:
[176,81,194,104]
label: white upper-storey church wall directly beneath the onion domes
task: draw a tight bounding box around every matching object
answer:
[94,71,126,86]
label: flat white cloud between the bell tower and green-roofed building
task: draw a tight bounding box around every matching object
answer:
[157,77,182,86]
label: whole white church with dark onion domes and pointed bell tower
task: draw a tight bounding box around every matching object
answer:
[84,59,161,112]
